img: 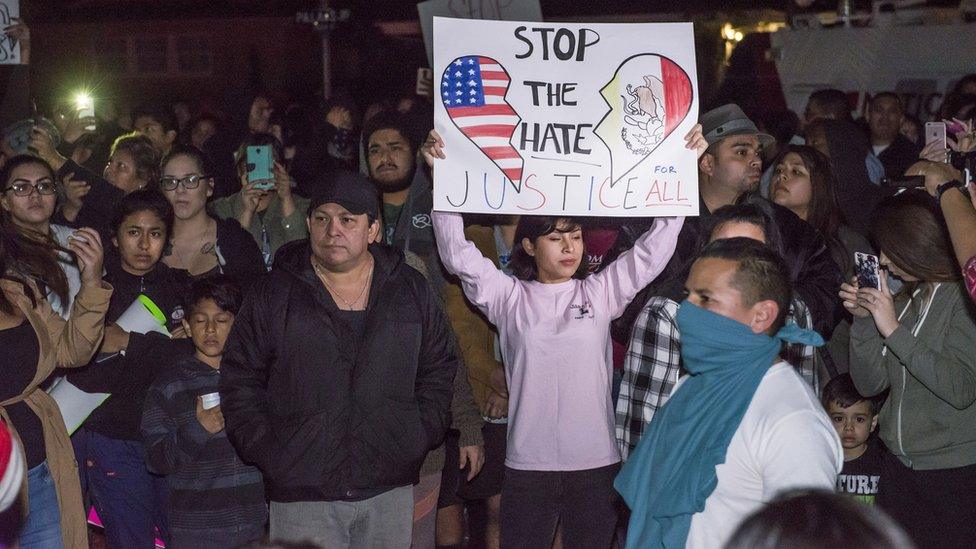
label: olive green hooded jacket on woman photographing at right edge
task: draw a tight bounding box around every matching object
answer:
[851,283,976,470]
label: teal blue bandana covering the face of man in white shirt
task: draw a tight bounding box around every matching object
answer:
[614,300,824,549]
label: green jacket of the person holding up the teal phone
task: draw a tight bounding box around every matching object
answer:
[209,191,308,268]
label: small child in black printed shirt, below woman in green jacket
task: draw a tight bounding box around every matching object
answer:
[821,374,886,505]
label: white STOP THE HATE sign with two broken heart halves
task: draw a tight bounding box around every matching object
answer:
[434,17,698,216]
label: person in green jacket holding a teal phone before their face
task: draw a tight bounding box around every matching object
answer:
[210,133,308,270]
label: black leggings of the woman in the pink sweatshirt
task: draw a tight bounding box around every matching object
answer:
[501,463,620,549]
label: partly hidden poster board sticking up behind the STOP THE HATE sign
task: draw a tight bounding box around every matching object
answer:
[417,0,542,67]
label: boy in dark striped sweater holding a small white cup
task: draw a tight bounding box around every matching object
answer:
[142,275,268,549]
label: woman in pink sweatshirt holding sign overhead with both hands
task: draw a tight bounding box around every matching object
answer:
[423,126,706,547]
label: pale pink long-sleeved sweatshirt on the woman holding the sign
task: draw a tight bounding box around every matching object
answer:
[433,212,684,471]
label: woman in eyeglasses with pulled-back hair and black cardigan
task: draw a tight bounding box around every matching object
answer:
[159,148,266,284]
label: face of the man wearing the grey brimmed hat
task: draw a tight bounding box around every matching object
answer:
[698,135,762,195]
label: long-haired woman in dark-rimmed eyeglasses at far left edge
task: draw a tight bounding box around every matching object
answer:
[0,154,81,318]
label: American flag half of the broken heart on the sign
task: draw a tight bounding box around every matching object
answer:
[441,55,524,192]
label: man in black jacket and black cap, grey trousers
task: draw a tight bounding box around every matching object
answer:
[220,176,458,547]
